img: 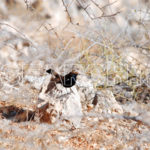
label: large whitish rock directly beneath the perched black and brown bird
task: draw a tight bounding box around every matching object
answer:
[38,75,83,128]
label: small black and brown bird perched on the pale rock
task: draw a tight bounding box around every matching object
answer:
[46,69,78,93]
